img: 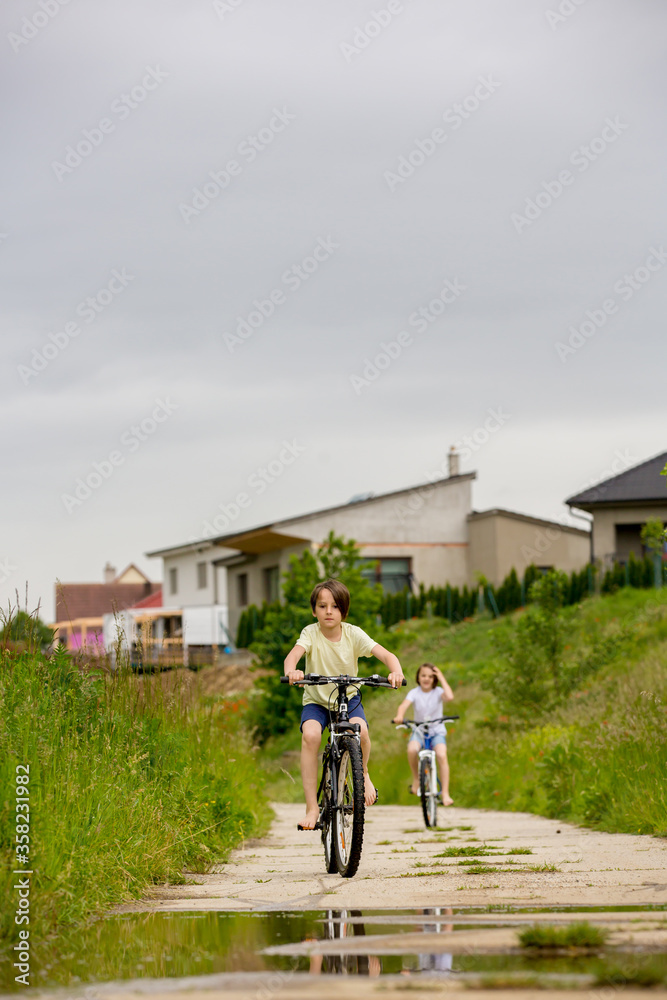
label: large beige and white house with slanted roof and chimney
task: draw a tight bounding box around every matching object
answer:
[147,453,589,635]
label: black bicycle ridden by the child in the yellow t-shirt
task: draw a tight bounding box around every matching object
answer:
[280,674,407,878]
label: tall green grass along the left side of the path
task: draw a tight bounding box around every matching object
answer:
[0,650,268,945]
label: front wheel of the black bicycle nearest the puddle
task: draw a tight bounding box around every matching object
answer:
[333,736,366,878]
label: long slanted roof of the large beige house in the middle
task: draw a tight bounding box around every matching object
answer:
[146,472,477,558]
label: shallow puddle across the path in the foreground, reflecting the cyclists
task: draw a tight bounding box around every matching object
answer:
[0,907,667,992]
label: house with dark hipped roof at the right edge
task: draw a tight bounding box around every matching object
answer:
[565,451,667,566]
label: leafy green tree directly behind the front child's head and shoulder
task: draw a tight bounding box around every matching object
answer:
[245,531,382,742]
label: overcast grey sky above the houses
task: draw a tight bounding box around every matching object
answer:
[0,0,667,619]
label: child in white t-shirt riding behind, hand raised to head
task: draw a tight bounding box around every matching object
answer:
[394,663,454,806]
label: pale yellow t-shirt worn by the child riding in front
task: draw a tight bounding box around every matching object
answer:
[296,622,377,708]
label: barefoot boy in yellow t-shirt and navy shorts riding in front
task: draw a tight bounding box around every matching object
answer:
[285,580,403,830]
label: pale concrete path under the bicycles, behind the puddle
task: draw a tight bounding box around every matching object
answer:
[117,804,667,912]
